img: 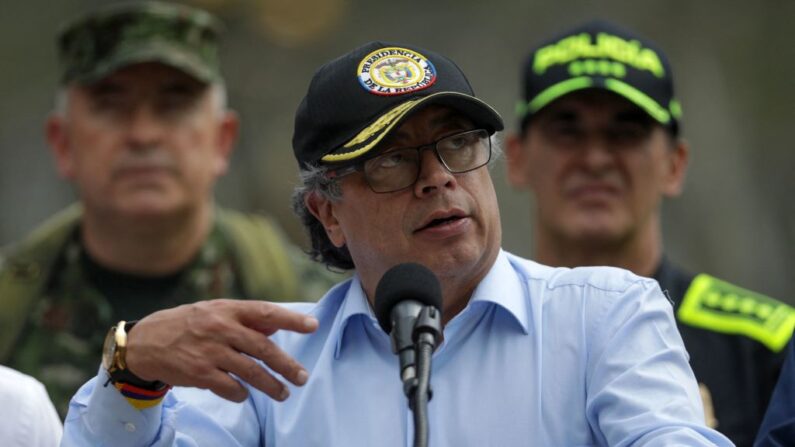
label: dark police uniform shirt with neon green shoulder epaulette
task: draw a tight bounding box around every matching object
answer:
[653,259,793,447]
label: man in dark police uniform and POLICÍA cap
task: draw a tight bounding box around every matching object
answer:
[506,22,795,446]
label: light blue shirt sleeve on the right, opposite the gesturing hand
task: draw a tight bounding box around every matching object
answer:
[586,279,732,446]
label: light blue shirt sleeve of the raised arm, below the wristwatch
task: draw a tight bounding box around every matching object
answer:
[61,368,260,447]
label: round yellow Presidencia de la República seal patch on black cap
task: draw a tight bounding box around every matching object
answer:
[356,47,436,96]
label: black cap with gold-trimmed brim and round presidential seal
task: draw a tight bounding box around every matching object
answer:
[293,42,503,168]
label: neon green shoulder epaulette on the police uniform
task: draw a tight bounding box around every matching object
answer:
[677,274,795,352]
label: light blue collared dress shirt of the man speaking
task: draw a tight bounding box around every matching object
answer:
[62,252,732,447]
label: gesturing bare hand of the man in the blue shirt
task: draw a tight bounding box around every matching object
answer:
[126,299,318,402]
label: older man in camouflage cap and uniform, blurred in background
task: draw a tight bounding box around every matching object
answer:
[0,3,339,414]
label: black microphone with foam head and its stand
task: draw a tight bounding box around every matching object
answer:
[374,263,442,446]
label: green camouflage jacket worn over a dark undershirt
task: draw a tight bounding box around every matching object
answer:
[0,205,342,415]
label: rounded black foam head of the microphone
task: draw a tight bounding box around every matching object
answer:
[374,262,442,334]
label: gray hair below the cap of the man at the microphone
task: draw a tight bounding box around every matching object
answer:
[292,133,502,270]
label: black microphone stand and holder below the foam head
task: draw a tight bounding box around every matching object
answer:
[403,306,442,447]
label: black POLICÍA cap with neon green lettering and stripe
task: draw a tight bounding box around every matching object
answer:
[516,20,682,134]
